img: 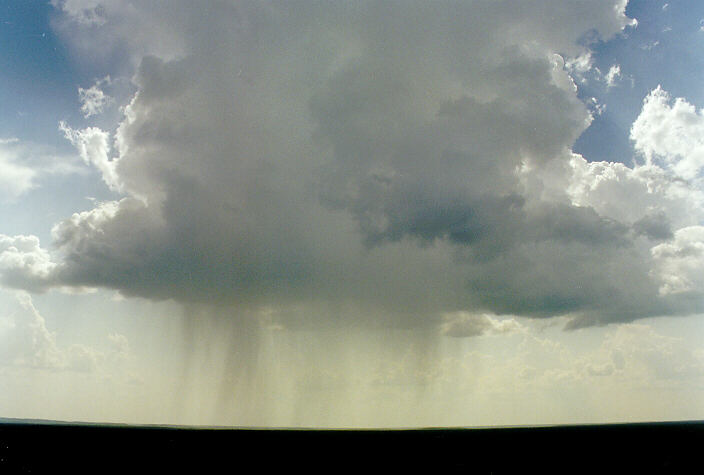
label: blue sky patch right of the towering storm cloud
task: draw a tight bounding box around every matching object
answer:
[575,1,704,163]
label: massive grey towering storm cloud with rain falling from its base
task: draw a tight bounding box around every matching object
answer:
[7,0,701,333]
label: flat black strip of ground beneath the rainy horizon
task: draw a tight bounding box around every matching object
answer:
[0,420,704,475]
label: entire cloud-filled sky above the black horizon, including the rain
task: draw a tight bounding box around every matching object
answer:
[0,0,704,428]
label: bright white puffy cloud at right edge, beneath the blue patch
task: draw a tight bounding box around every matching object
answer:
[631,86,704,180]
